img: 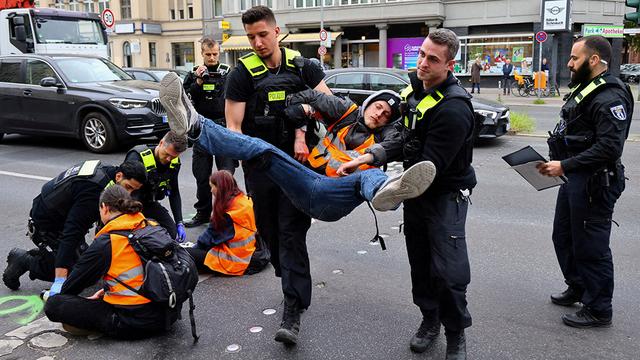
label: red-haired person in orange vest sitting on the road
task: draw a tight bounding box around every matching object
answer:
[187,170,256,275]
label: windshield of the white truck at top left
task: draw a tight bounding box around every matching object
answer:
[35,16,106,45]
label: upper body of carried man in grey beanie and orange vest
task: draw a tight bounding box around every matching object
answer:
[285,89,405,177]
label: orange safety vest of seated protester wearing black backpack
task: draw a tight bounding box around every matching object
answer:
[96,213,151,305]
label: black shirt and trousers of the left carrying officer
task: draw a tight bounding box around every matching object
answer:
[225,49,324,309]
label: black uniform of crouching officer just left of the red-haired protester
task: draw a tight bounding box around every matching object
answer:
[125,145,182,239]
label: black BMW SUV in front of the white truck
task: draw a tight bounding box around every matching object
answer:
[0,54,169,153]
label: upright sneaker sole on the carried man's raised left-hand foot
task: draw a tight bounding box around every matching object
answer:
[160,73,189,135]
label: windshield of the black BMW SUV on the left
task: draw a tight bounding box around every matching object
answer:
[56,57,132,83]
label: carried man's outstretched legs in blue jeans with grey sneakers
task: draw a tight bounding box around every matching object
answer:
[160,74,435,221]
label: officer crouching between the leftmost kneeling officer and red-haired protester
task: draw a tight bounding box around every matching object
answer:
[125,131,187,242]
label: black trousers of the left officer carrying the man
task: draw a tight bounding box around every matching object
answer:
[244,167,311,309]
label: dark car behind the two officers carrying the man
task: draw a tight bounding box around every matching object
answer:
[324,68,509,138]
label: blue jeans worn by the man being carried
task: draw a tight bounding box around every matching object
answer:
[197,116,387,221]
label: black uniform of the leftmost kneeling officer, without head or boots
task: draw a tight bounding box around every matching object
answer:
[29,163,118,281]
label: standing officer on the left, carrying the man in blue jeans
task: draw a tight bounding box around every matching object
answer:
[225,6,331,344]
